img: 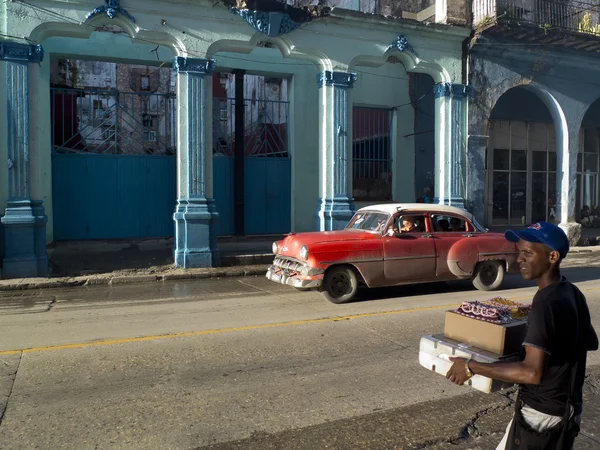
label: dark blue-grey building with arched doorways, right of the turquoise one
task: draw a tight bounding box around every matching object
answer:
[467,0,600,243]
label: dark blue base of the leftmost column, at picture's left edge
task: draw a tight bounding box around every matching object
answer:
[2,200,48,278]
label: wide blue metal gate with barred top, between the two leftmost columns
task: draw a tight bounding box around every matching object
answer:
[51,88,177,240]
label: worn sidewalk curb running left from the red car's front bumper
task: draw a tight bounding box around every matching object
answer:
[0,265,267,292]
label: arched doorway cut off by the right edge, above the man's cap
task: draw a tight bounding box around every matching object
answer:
[575,99,600,226]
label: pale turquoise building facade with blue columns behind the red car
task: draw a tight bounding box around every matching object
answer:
[0,0,470,278]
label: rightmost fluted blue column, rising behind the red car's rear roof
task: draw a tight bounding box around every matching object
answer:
[434,83,468,208]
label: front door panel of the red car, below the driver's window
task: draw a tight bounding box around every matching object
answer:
[382,216,436,285]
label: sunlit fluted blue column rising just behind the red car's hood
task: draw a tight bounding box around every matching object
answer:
[316,71,356,231]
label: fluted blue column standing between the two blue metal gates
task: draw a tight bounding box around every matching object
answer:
[173,57,219,268]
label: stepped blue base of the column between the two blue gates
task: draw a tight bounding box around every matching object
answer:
[173,199,218,269]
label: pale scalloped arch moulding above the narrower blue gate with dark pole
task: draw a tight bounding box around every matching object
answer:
[206,32,333,72]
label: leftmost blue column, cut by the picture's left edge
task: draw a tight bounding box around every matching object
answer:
[0,41,48,278]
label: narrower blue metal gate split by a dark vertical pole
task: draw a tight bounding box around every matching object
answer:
[213,98,291,235]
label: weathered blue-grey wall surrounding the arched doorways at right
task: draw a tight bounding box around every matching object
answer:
[467,36,600,224]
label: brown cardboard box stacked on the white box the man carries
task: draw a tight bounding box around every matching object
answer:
[444,311,527,356]
